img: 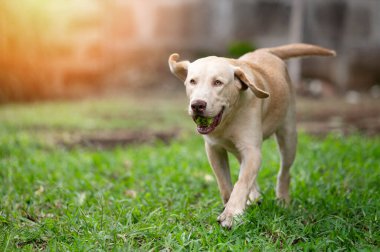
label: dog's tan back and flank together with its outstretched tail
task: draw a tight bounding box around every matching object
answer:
[238,44,335,137]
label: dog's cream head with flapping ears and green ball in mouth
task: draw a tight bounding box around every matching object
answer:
[169,54,269,134]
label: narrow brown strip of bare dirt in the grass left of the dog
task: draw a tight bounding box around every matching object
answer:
[58,130,179,149]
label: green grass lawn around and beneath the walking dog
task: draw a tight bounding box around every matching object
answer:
[0,94,380,251]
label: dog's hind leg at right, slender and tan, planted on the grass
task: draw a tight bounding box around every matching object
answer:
[276,104,297,203]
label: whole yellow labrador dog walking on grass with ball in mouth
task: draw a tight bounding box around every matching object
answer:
[169,44,335,228]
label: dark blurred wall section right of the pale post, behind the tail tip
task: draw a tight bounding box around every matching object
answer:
[303,0,380,90]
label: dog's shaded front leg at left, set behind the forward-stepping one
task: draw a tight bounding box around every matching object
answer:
[205,142,232,204]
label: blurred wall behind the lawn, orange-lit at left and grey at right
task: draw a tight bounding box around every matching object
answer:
[0,0,380,101]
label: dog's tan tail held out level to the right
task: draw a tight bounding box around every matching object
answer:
[265,43,336,60]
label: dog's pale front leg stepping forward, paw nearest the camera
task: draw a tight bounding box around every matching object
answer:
[218,147,261,228]
